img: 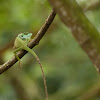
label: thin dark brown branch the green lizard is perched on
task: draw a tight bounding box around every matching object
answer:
[0,10,56,74]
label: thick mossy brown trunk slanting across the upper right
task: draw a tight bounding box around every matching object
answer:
[49,0,100,72]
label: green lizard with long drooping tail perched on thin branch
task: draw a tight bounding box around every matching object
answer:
[14,32,48,100]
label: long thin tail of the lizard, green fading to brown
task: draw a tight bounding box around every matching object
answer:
[23,46,48,100]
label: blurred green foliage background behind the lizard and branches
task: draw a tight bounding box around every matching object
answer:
[0,0,100,100]
